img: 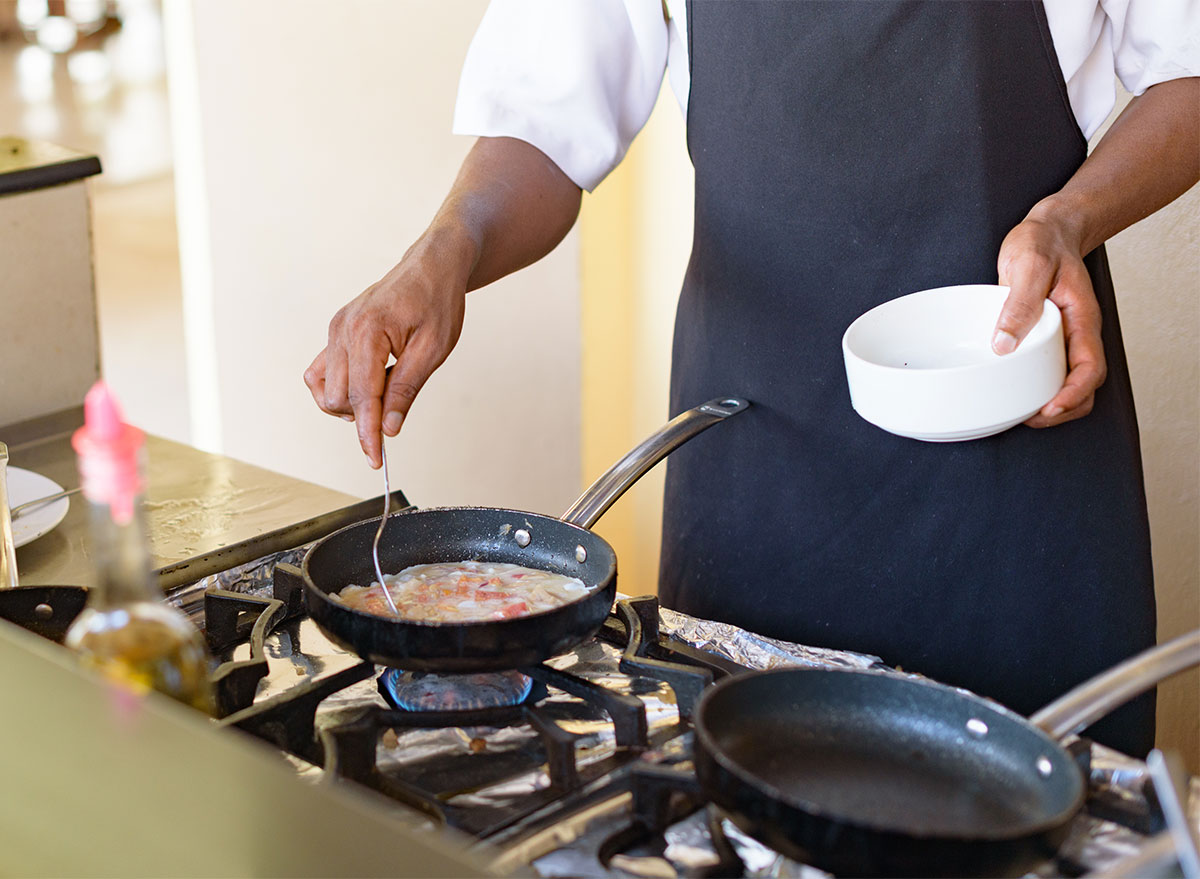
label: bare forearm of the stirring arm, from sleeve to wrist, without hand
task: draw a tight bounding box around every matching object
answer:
[414,137,581,291]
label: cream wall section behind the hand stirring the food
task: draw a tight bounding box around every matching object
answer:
[167,0,580,514]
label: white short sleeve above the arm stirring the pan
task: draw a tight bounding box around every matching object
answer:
[454,0,667,191]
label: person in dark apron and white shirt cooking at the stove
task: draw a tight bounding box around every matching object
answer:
[305,0,1200,755]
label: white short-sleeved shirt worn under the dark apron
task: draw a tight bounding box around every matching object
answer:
[454,0,1200,191]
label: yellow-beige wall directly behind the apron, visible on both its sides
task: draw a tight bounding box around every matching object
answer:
[582,89,1200,758]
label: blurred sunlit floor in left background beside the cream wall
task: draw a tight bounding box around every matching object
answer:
[0,0,190,440]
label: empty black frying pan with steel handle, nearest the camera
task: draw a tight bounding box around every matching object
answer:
[695,630,1200,877]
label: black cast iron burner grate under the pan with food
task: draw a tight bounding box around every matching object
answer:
[194,563,720,836]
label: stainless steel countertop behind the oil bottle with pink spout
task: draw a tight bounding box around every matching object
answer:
[0,409,358,586]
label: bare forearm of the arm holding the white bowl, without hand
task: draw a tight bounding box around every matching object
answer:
[1028,77,1200,256]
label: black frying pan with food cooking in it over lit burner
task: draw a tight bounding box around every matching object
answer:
[301,397,749,674]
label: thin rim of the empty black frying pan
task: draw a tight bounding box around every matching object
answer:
[692,666,1087,843]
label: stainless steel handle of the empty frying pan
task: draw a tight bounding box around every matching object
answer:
[1030,629,1200,739]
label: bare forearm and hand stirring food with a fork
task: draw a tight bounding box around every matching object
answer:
[305,138,581,467]
